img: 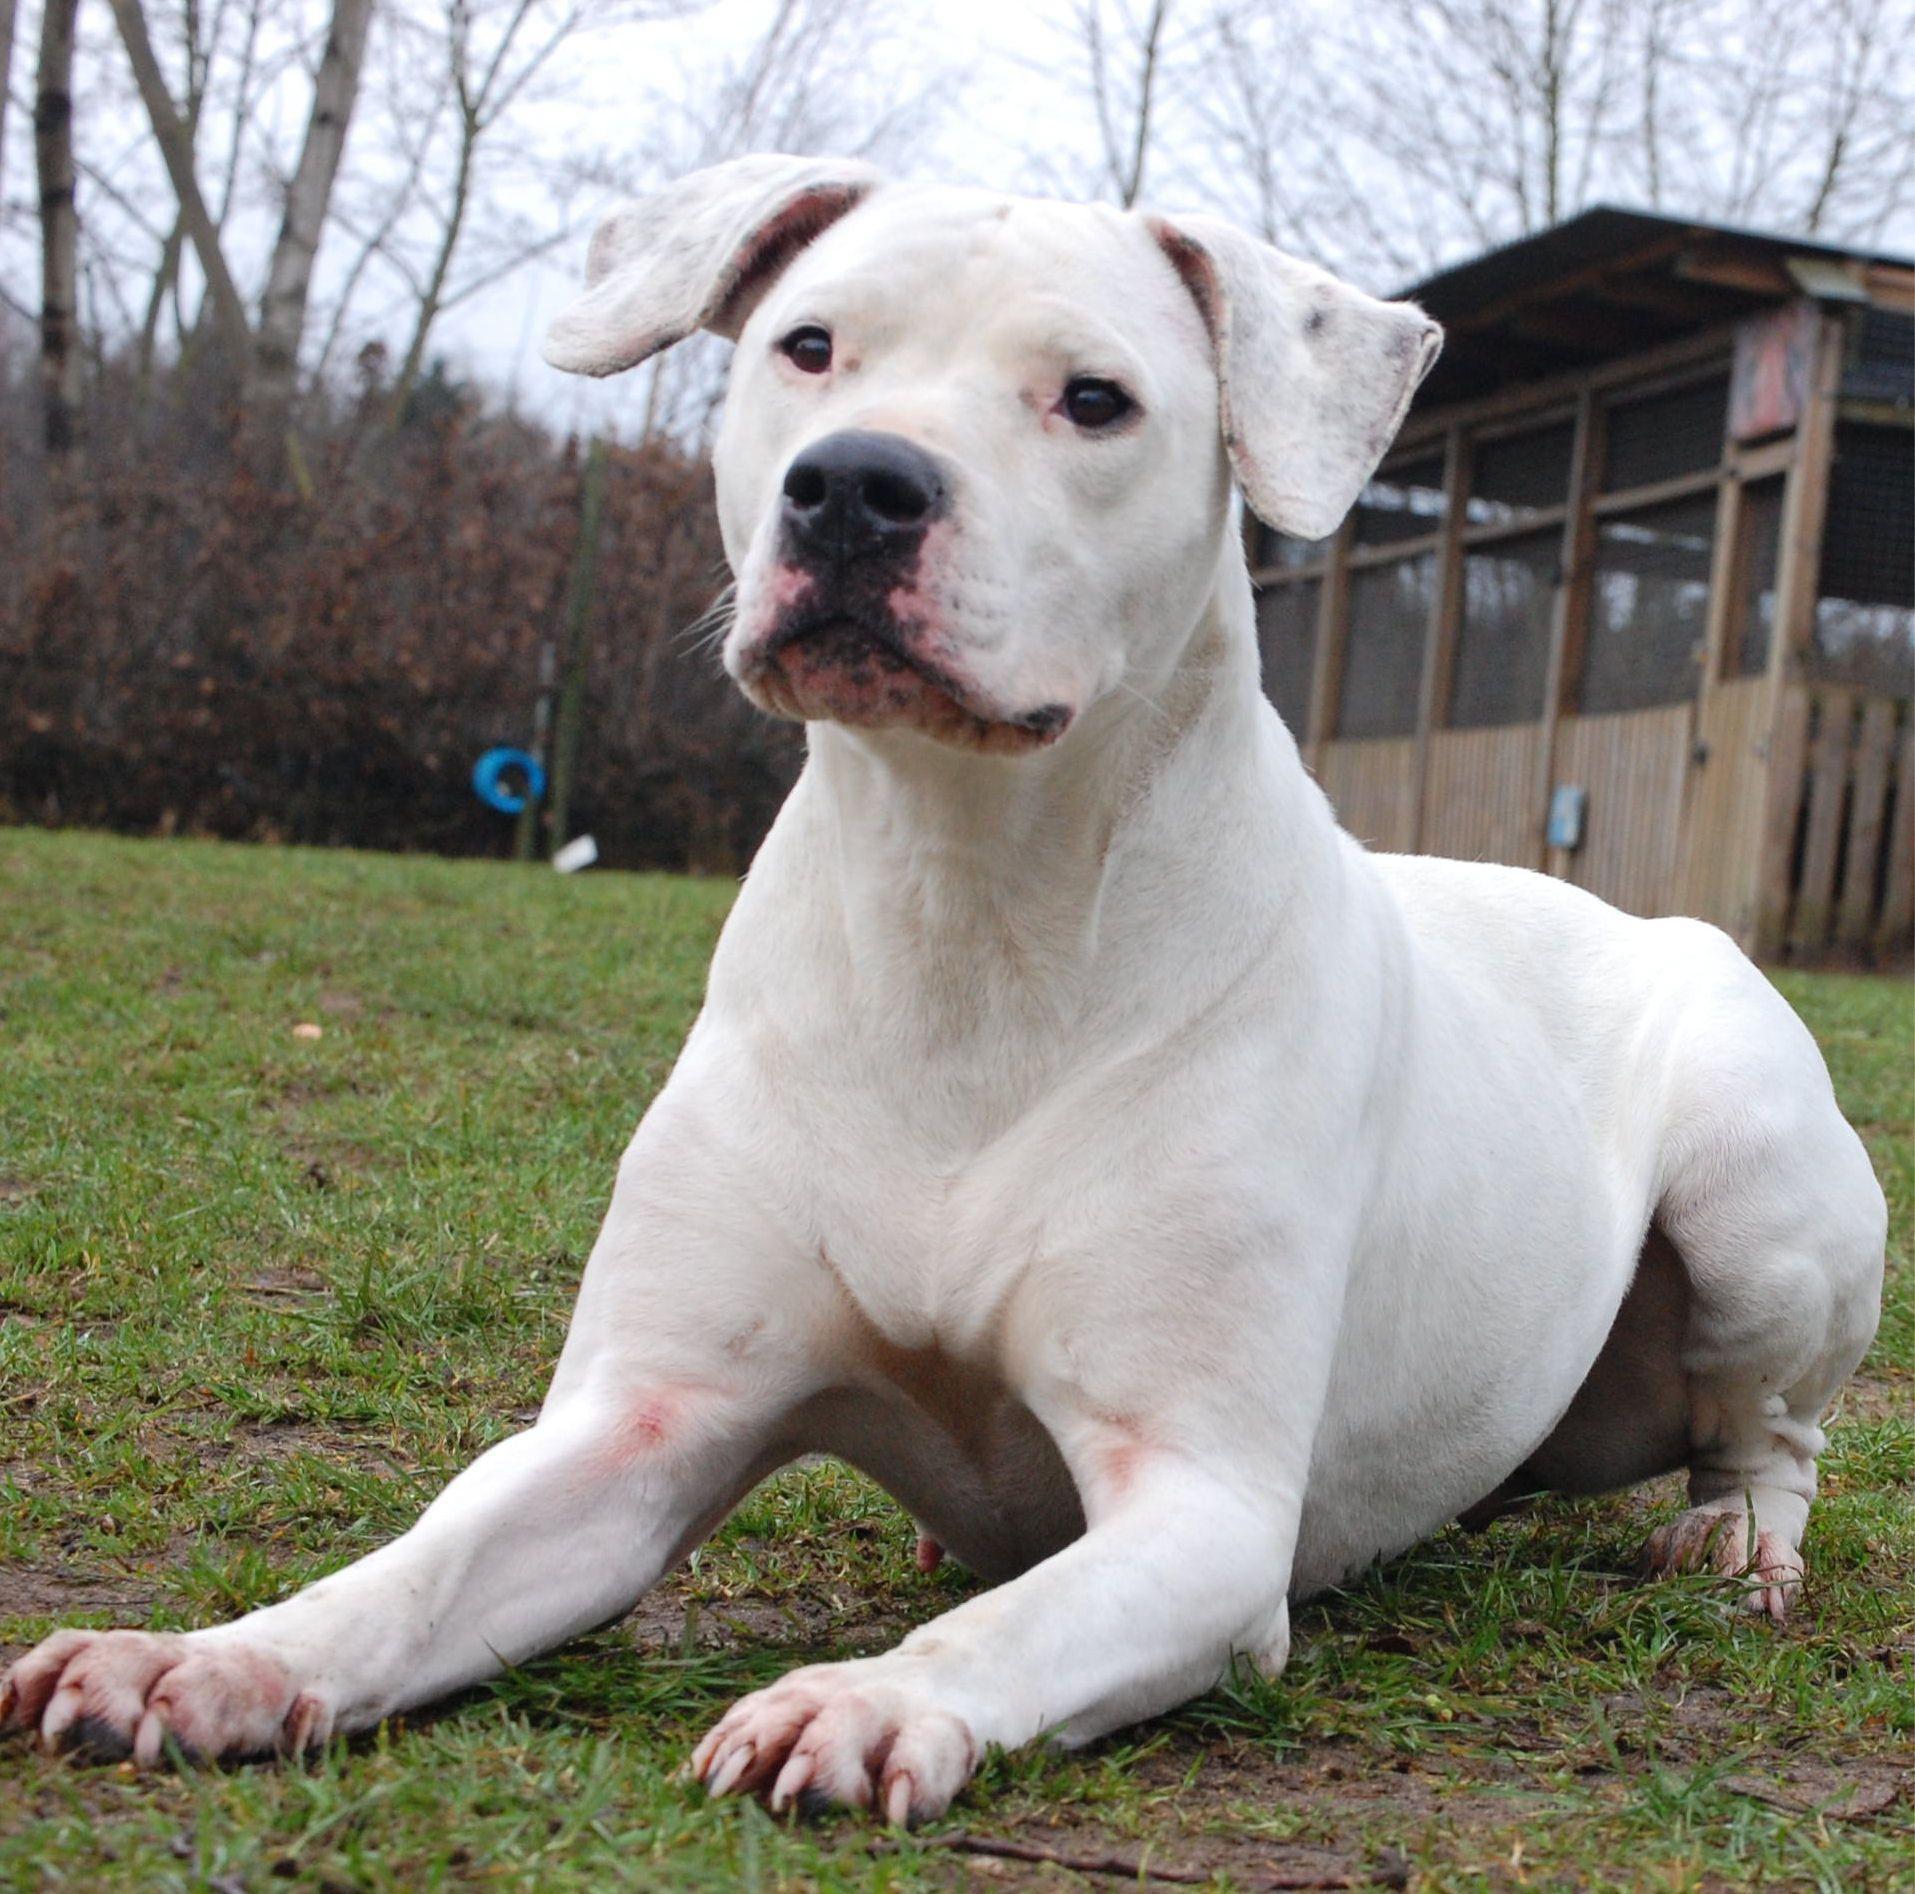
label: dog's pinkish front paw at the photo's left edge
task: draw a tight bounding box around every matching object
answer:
[0,1632,331,1768]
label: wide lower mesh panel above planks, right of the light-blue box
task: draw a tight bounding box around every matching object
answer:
[1582,492,1716,716]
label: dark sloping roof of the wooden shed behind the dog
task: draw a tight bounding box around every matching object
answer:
[1398,205,1915,406]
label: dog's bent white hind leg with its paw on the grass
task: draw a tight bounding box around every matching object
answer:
[1645,961,1886,1620]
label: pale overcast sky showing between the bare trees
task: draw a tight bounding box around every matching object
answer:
[0,0,1915,431]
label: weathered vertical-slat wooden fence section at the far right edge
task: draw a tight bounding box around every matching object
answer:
[1771,684,1915,959]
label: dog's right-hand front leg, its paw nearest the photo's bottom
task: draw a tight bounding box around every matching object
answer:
[693,1233,1337,1821]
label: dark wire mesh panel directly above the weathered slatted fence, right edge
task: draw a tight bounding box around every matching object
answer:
[1804,421,1915,697]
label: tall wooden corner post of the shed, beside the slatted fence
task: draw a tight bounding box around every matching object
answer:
[1745,316,1842,958]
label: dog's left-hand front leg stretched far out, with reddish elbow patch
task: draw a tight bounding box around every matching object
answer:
[0,1120,831,1762]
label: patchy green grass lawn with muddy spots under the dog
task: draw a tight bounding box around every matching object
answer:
[0,831,1915,1894]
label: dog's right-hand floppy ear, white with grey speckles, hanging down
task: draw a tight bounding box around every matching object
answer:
[1149,214,1442,540]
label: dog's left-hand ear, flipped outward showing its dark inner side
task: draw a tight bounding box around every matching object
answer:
[546,155,883,375]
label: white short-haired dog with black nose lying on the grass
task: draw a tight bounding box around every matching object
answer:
[0,157,1884,1819]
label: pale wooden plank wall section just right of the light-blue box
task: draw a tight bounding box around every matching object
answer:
[1551,703,1695,913]
